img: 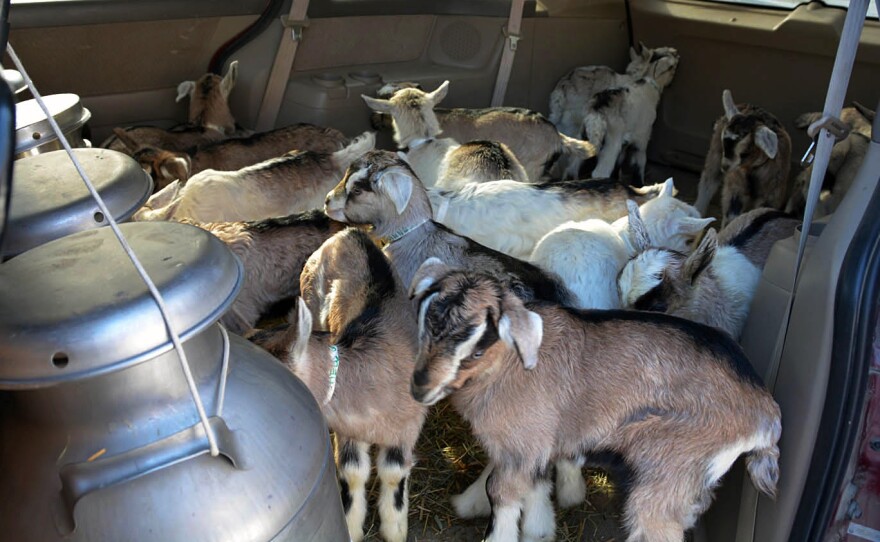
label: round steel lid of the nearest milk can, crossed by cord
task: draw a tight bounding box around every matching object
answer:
[0,222,243,389]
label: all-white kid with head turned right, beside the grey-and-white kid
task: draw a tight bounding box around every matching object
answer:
[529,179,714,309]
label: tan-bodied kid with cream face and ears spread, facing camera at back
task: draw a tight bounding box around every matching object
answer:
[363,81,596,182]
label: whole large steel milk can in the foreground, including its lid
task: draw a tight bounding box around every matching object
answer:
[0,222,349,542]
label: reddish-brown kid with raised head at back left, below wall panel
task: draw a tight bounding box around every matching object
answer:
[101,60,238,154]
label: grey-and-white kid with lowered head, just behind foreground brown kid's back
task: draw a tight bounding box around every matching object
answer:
[618,208,798,338]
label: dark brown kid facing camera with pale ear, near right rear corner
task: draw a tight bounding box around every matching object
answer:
[694,90,791,228]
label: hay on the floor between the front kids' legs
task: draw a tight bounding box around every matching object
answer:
[354,401,623,542]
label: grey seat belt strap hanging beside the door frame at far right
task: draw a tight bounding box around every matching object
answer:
[736,0,880,542]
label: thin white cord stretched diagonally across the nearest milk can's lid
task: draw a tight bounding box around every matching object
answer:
[6,43,222,457]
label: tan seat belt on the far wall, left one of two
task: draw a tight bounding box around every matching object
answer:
[255,0,309,132]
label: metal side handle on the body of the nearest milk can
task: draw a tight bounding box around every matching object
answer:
[56,416,247,536]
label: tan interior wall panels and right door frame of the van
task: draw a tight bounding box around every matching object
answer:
[3,0,880,542]
